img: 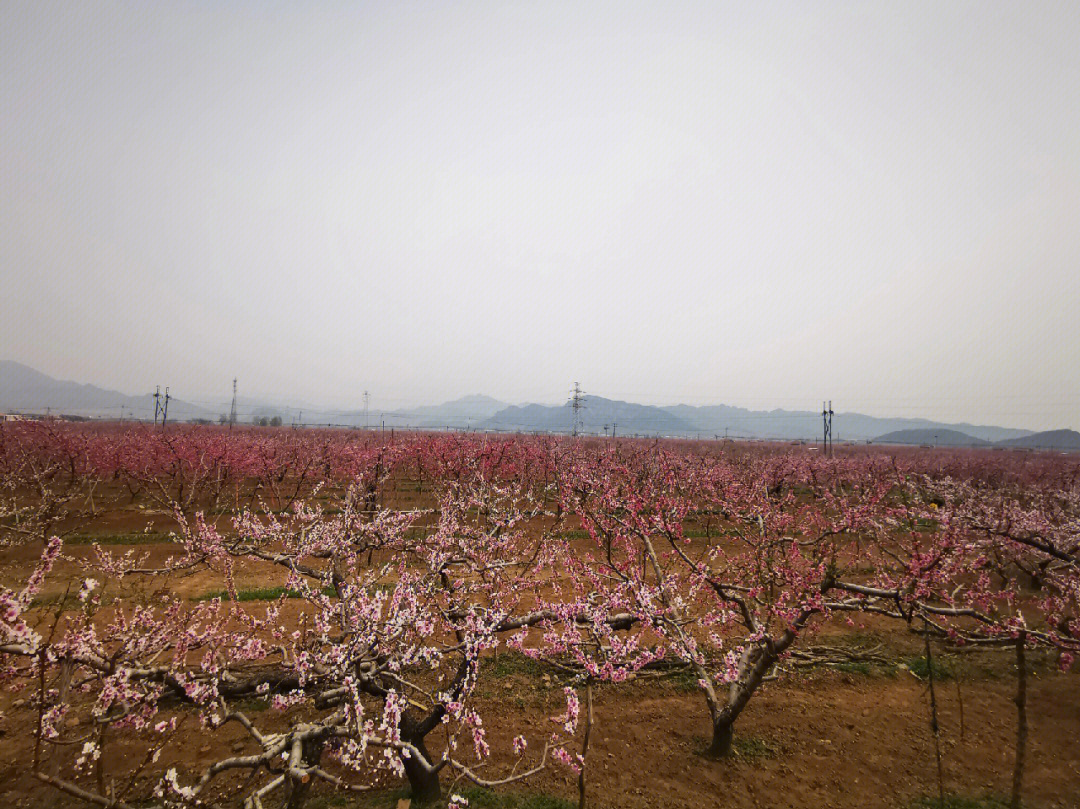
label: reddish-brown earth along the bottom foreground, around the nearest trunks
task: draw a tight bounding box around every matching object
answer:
[6,648,1080,809]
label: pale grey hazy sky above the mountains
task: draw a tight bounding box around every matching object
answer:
[0,0,1080,429]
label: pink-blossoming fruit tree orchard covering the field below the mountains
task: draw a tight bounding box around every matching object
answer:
[0,423,1080,809]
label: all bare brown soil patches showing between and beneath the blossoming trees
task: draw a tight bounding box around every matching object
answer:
[0,483,1080,809]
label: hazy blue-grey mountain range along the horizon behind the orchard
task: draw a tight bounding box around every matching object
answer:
[0,360,1080,450]
